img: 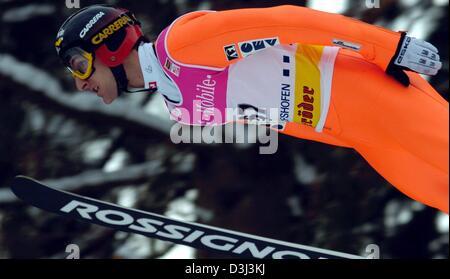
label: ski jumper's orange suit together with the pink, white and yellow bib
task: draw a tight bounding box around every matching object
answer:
[156,6,449,213]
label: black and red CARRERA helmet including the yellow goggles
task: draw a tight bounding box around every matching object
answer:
[55,5,145,94]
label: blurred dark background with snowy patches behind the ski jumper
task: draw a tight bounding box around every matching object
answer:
[0,0,449,258]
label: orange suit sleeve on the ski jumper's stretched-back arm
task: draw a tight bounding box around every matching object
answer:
[167,5,401,70]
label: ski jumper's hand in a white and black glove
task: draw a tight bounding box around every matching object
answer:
[386,33,442,86]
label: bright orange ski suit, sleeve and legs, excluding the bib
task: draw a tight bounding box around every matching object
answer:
[163,6,449,214]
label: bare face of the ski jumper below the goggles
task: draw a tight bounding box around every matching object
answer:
[75,59,118,104]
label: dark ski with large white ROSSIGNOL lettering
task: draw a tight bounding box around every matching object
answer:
[11,176,363,259]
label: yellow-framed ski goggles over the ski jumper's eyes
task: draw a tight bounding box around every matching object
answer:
[63,47,95,80]
